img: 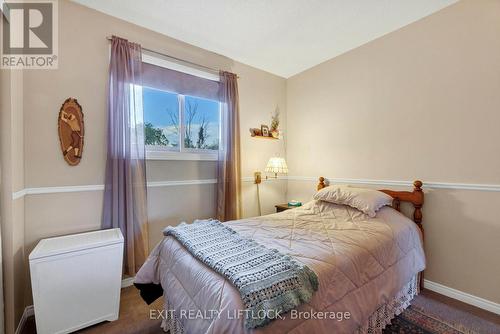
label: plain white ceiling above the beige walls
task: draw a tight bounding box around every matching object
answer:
[74,0,457,78]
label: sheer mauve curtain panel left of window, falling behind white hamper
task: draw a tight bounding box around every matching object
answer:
[102,36,148,276]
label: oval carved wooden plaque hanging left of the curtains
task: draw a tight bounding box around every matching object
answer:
[57,97,85,166]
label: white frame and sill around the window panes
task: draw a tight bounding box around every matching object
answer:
[142,52,220,161]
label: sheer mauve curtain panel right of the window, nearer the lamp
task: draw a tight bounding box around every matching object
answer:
[217,71,241,221]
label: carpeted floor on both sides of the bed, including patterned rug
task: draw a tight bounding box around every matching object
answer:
[21,287,500,334]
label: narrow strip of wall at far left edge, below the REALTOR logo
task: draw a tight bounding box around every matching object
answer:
[0,66,26,334]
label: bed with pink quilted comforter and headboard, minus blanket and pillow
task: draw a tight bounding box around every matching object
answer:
[135,178,425,334]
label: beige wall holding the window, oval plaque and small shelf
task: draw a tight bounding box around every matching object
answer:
[2,1,286,330]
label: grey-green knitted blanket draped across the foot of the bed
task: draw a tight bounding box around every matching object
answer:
[163,220,318,328]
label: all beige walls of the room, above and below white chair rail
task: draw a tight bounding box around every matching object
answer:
[4,0,500,333]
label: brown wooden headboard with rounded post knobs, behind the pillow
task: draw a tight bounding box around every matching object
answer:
[317,176,424,232]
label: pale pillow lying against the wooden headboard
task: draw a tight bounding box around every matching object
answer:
[313,185,393,218]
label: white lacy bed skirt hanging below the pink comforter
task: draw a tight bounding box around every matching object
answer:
[161,274,420,334]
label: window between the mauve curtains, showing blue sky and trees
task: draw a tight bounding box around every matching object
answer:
[142,52,221,160]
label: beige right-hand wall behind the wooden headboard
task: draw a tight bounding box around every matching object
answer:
[287,0,500,303]
